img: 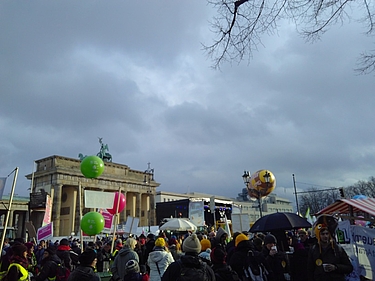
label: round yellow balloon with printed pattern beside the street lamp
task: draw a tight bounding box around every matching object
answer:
[247,170,276,199]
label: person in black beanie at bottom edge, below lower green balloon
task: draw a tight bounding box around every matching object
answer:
[67,249,101,281]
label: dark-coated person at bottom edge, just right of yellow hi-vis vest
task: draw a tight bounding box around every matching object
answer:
[35,246,61,281]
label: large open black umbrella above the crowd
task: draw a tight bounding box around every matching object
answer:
[250,213,311,232]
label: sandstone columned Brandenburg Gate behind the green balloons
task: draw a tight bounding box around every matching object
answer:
[26,155,159,236]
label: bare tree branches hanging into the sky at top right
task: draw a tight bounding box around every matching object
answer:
[204,0,375,73]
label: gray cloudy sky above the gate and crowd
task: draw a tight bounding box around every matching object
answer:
[0,0,375,208]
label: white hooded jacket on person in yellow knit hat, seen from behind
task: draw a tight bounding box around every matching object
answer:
[147,247,174,281]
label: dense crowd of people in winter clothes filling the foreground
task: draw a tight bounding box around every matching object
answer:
[1,224,353,281]
